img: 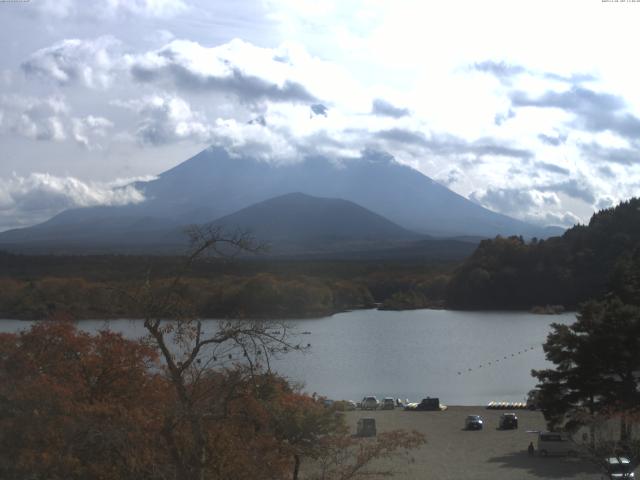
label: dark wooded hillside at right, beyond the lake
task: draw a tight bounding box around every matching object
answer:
[447,198,640,309]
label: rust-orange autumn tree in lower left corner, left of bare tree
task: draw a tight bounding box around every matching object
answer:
[0,321,166,480]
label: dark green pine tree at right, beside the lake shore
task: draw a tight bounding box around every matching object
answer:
[532,297,640,440]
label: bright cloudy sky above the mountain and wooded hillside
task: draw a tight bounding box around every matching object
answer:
[0,0,640,231]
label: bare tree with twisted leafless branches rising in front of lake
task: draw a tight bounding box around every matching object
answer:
[132,226,304,480]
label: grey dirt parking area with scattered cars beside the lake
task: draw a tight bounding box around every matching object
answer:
[346,407,602,480]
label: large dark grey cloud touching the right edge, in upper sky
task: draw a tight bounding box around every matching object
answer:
[511,87,640,139]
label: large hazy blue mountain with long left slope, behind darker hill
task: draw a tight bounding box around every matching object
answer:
[0,147,556,248]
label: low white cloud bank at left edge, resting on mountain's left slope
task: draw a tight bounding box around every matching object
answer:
[0,173,144,230]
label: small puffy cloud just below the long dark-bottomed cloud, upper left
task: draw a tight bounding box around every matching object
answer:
[113,93,213,145]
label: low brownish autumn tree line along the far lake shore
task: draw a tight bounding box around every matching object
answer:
[0,256,449,319]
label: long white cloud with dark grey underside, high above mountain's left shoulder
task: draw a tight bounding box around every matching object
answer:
[128,40,317,103]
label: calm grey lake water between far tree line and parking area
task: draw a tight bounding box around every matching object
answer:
[0,310,575,405]
